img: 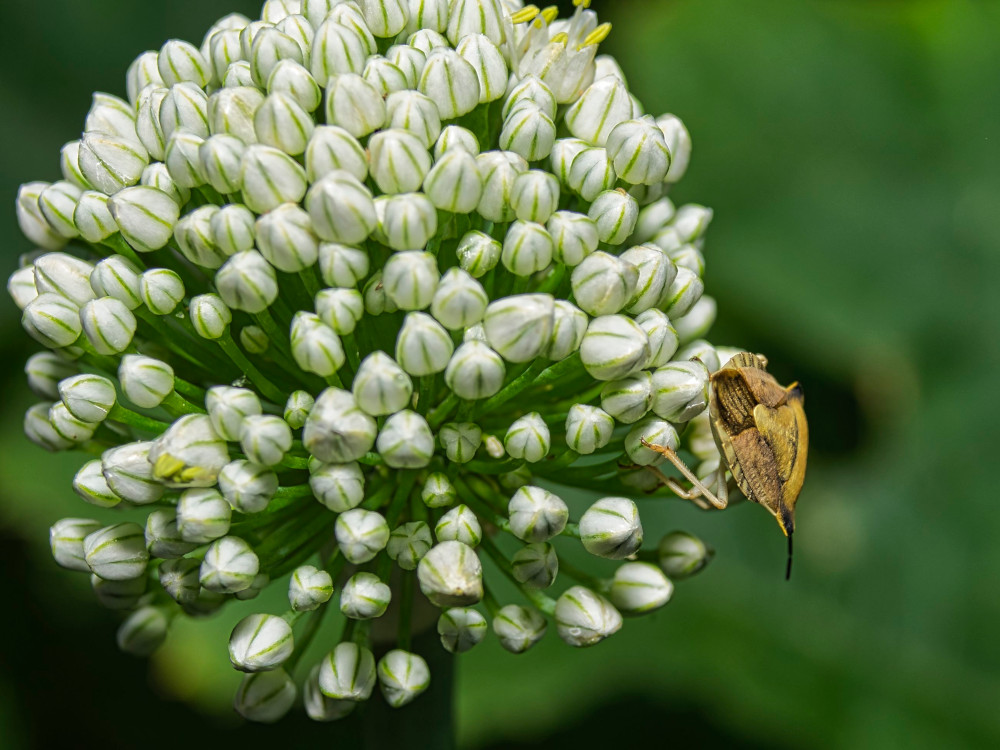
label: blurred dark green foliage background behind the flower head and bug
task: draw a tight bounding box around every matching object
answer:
[0,0,1000,748]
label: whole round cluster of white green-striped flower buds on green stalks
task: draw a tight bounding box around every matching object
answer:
[8,0,728,722]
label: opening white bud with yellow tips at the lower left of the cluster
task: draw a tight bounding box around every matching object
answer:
[149,414,229,487]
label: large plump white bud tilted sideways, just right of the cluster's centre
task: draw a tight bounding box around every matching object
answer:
[483,294,555,362]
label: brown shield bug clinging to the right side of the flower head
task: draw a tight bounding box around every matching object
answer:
[647,352,809,578]
